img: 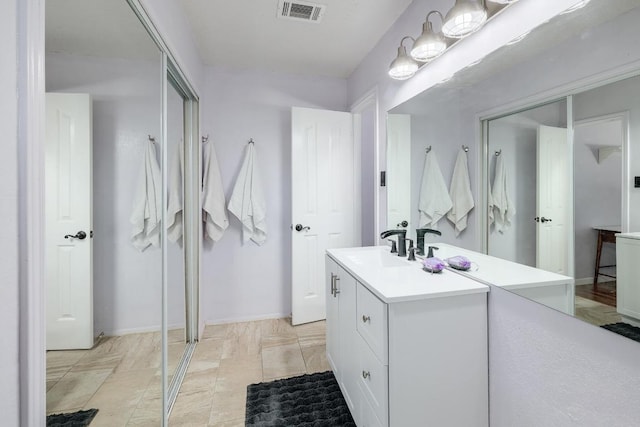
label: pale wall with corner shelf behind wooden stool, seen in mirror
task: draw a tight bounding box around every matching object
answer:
[573,120,623,282]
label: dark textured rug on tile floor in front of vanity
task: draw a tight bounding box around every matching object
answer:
[245,371,355,427]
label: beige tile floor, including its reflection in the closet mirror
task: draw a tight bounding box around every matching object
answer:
[47,319,329,427]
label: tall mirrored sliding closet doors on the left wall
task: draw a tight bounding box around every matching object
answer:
[45,0,199,425]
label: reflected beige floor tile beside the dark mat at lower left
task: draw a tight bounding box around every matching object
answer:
[47,369,111,413]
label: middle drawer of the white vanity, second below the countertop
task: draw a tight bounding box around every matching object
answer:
[357,338,389,424]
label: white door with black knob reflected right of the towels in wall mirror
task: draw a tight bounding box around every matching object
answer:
[536,126,573,274]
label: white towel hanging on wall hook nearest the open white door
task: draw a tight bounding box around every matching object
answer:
[228,144,267,245]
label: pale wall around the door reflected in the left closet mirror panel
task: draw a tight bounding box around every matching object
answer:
[46,53,168,335]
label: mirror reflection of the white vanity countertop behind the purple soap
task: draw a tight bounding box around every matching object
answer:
[425,244,572,289]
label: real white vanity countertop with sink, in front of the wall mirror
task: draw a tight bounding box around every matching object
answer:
[327,246,489,303]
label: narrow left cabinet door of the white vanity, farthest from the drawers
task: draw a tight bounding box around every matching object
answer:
[325,256,341,376]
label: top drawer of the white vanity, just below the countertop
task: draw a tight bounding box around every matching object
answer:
[356,283,389,365]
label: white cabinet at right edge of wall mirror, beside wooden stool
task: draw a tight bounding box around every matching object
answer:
[616,233,640,326]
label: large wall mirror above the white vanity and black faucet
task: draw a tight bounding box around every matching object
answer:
[387,0,640,342]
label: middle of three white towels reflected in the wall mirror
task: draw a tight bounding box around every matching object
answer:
[447,149,474,237]
